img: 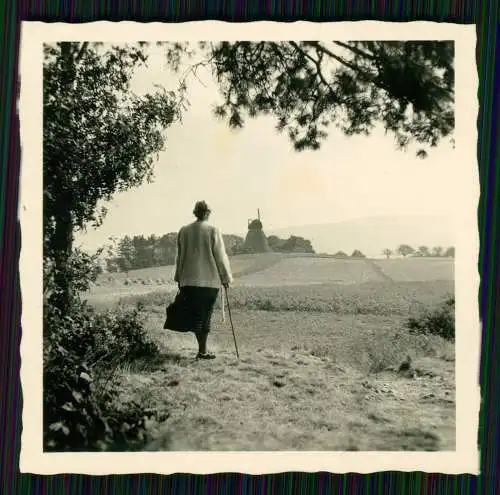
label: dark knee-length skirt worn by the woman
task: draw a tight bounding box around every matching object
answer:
[165,286,219,334]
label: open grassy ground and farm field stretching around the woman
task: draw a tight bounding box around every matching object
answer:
[84,254,455,451]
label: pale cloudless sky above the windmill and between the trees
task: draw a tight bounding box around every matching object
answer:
[76,44,456,250]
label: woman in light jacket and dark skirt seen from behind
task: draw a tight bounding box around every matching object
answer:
[174,201,232,359]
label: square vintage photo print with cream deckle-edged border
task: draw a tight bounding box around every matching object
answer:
[20,23,479,472]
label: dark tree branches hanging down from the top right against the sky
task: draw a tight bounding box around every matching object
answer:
[193,41,455,158]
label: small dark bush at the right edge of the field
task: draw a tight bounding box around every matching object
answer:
[407,297,455,341]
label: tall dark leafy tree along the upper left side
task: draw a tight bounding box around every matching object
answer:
[43,42,180,311]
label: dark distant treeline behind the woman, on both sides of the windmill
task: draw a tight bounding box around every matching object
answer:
[105,232,314,273]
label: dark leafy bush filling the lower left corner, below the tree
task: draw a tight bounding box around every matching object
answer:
[43,258,159,451]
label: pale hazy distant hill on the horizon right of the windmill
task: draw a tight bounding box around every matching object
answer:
[267,215,455,257]
